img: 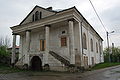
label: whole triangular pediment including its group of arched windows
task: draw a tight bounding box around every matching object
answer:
[19,6,56,25]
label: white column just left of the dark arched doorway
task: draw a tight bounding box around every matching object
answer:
[25,30,30,65]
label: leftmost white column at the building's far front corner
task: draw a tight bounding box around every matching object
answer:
[11,34,16,66]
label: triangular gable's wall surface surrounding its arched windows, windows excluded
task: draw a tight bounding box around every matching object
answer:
[19,5,56,25]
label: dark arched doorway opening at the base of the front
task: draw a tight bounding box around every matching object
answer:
[31,56,42,71]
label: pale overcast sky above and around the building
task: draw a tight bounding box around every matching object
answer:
[0,0,120,47]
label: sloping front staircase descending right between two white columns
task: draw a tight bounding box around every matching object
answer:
[49,51,70,66]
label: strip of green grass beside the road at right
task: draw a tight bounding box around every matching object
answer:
[92,63,120,70]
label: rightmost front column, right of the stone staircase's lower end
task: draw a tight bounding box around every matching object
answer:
[69,20,75,64]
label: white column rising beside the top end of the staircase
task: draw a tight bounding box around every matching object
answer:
[45,25,50,64]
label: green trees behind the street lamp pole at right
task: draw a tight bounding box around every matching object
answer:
[103,47,120,62]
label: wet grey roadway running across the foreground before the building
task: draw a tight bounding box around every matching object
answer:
[0,66,120,80]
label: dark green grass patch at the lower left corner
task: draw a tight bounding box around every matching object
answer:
[0,64,22,74]
